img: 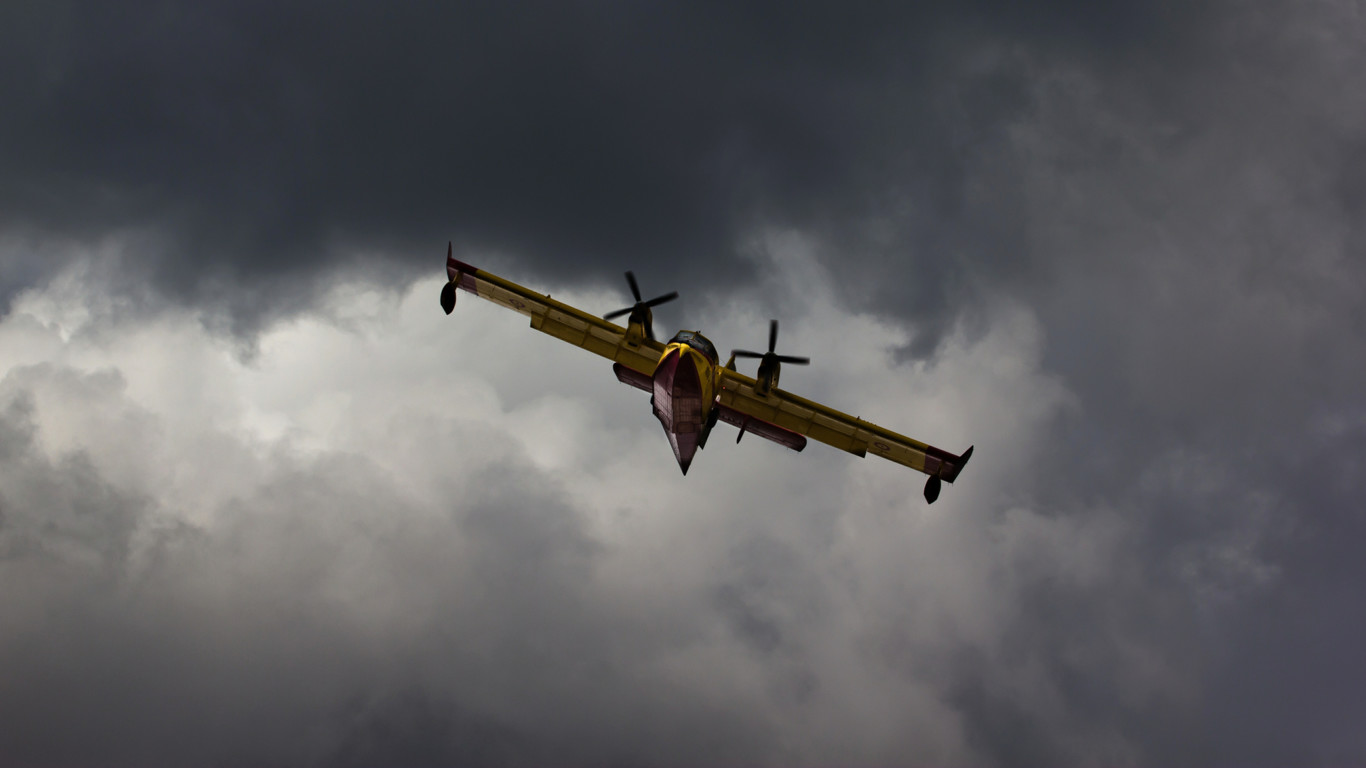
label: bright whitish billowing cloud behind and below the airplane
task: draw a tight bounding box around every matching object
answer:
[0,235,1278,764]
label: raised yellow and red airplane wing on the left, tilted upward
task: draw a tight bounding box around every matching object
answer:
[441,246,664,376]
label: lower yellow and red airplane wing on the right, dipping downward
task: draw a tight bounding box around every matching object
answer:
[720,369,973,502]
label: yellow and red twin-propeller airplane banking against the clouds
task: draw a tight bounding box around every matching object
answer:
[441,243,973,504]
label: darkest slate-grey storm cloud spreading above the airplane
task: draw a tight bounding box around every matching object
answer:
[0,1,1194,328]
